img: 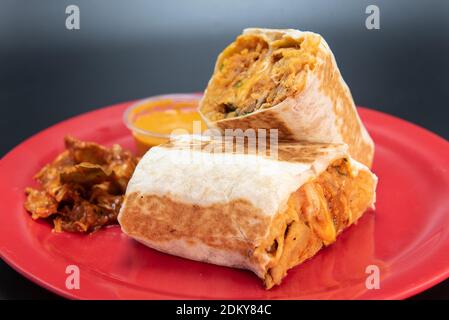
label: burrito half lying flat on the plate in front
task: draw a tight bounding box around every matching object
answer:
[118,136,377,288]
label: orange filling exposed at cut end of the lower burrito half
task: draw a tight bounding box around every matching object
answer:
[256,159,374,288]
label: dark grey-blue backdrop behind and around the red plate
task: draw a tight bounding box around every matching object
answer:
[0,0,449,299]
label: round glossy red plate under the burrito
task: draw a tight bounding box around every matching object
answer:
[0,94,449,299]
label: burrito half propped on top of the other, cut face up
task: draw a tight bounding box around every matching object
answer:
[199,29,374,167]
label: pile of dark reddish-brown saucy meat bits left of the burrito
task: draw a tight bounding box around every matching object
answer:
[25,136,138,233]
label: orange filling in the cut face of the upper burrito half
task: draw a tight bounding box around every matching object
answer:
[201,35,320,121]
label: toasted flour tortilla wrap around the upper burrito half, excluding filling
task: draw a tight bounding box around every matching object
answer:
[198,28,374,168]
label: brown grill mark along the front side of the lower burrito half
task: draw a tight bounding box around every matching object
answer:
[120,193,271,256]
